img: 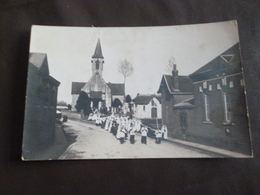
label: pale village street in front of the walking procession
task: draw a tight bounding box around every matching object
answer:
[59,120,214,159]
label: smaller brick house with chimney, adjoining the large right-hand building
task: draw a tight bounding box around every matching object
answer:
[158,64,194,138]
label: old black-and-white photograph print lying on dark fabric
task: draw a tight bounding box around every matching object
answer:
[22,21,253,161]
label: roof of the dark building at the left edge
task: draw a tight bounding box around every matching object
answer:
[29,53,50,74]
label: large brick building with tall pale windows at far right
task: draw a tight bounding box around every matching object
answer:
[189,43,251,154]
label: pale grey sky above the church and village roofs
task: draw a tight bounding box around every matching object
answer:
[30,21,239,104]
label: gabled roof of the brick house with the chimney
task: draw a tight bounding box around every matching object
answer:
[157,75,193,94]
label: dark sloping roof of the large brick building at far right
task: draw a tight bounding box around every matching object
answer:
[189,43,241,81]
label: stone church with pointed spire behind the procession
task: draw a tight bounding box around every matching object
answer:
[71,39,125,110]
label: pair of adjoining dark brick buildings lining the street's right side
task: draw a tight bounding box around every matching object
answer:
[158,43,251,154]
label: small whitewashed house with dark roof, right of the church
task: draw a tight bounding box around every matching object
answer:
[133,94,162,119]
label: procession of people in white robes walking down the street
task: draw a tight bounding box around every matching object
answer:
[88,110,168,144]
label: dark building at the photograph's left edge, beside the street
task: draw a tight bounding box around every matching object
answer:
[23,53,60,158]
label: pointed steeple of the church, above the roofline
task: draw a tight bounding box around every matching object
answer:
[91,39,104,76]
